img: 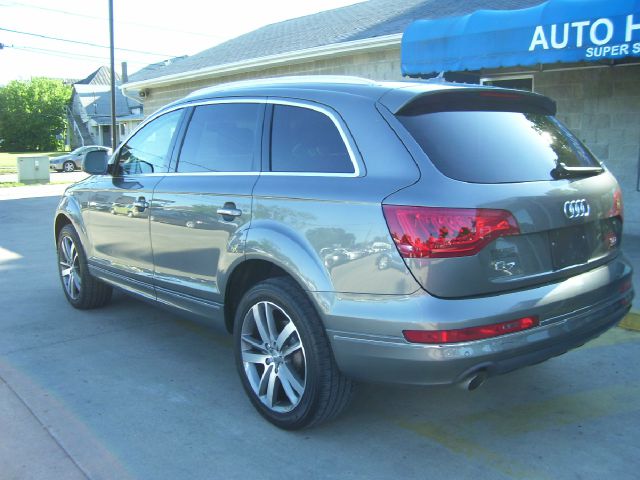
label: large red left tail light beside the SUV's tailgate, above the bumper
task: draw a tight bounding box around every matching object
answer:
[383,205,520,258]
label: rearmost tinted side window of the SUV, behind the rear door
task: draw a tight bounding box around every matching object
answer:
[271,105,354,173]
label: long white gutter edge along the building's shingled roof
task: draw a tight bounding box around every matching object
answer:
[121,33,402,90]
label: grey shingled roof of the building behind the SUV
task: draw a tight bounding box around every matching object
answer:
[129,0,543,82]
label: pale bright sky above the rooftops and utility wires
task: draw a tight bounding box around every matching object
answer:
[0,0,358,85]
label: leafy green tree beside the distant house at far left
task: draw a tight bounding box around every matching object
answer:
[0,78,71,151]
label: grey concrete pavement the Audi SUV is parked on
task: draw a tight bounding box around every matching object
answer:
[0,189,640,480]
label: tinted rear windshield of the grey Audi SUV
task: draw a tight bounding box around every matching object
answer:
[398,111,600,183]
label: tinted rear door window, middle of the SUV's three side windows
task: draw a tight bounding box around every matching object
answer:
[177,103,264,173]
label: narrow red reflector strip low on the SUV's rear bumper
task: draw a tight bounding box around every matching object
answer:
[402,316,539,344]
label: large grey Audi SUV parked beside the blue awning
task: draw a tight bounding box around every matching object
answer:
[55,77,633,429]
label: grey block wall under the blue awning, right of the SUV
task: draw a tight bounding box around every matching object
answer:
[534,65,640,235]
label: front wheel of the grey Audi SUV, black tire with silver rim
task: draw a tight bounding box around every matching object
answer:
[57,225,113,310]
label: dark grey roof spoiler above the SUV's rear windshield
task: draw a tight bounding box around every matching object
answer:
[380,87,557,115]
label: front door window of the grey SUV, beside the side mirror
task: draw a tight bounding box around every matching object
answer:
[118,110,182,175]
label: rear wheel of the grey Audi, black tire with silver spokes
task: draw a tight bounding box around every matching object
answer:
[234,277,353,430]
